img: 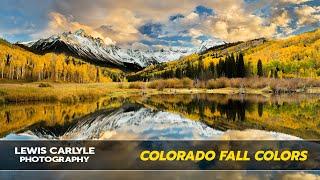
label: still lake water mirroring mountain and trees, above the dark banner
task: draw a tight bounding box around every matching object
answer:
[0,94,320,139]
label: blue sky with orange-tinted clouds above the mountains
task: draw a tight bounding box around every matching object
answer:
[0,0,320,48]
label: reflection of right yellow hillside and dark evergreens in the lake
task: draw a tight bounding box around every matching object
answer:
[135,94,320,139]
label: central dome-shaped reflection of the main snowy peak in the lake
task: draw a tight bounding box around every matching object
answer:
[60,105,221,139]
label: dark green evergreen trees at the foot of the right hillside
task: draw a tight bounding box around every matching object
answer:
[128,52,266,81]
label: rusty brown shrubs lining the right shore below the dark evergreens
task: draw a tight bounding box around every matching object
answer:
[127,77,320,93]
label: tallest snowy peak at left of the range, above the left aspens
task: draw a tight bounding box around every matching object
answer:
[30,29,149,69]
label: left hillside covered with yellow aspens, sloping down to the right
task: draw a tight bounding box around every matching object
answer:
[0,40,123,83]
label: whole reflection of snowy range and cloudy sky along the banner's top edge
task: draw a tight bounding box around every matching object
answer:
[4,104,301,140]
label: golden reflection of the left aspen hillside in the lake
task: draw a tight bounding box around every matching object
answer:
[0,98,123,137]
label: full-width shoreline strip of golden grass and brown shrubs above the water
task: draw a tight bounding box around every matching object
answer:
[0,78,320,104]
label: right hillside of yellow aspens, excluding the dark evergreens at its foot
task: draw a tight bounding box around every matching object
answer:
[128,29,320,80]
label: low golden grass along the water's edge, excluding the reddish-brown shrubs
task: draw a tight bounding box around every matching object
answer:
[0,79,320,104]
